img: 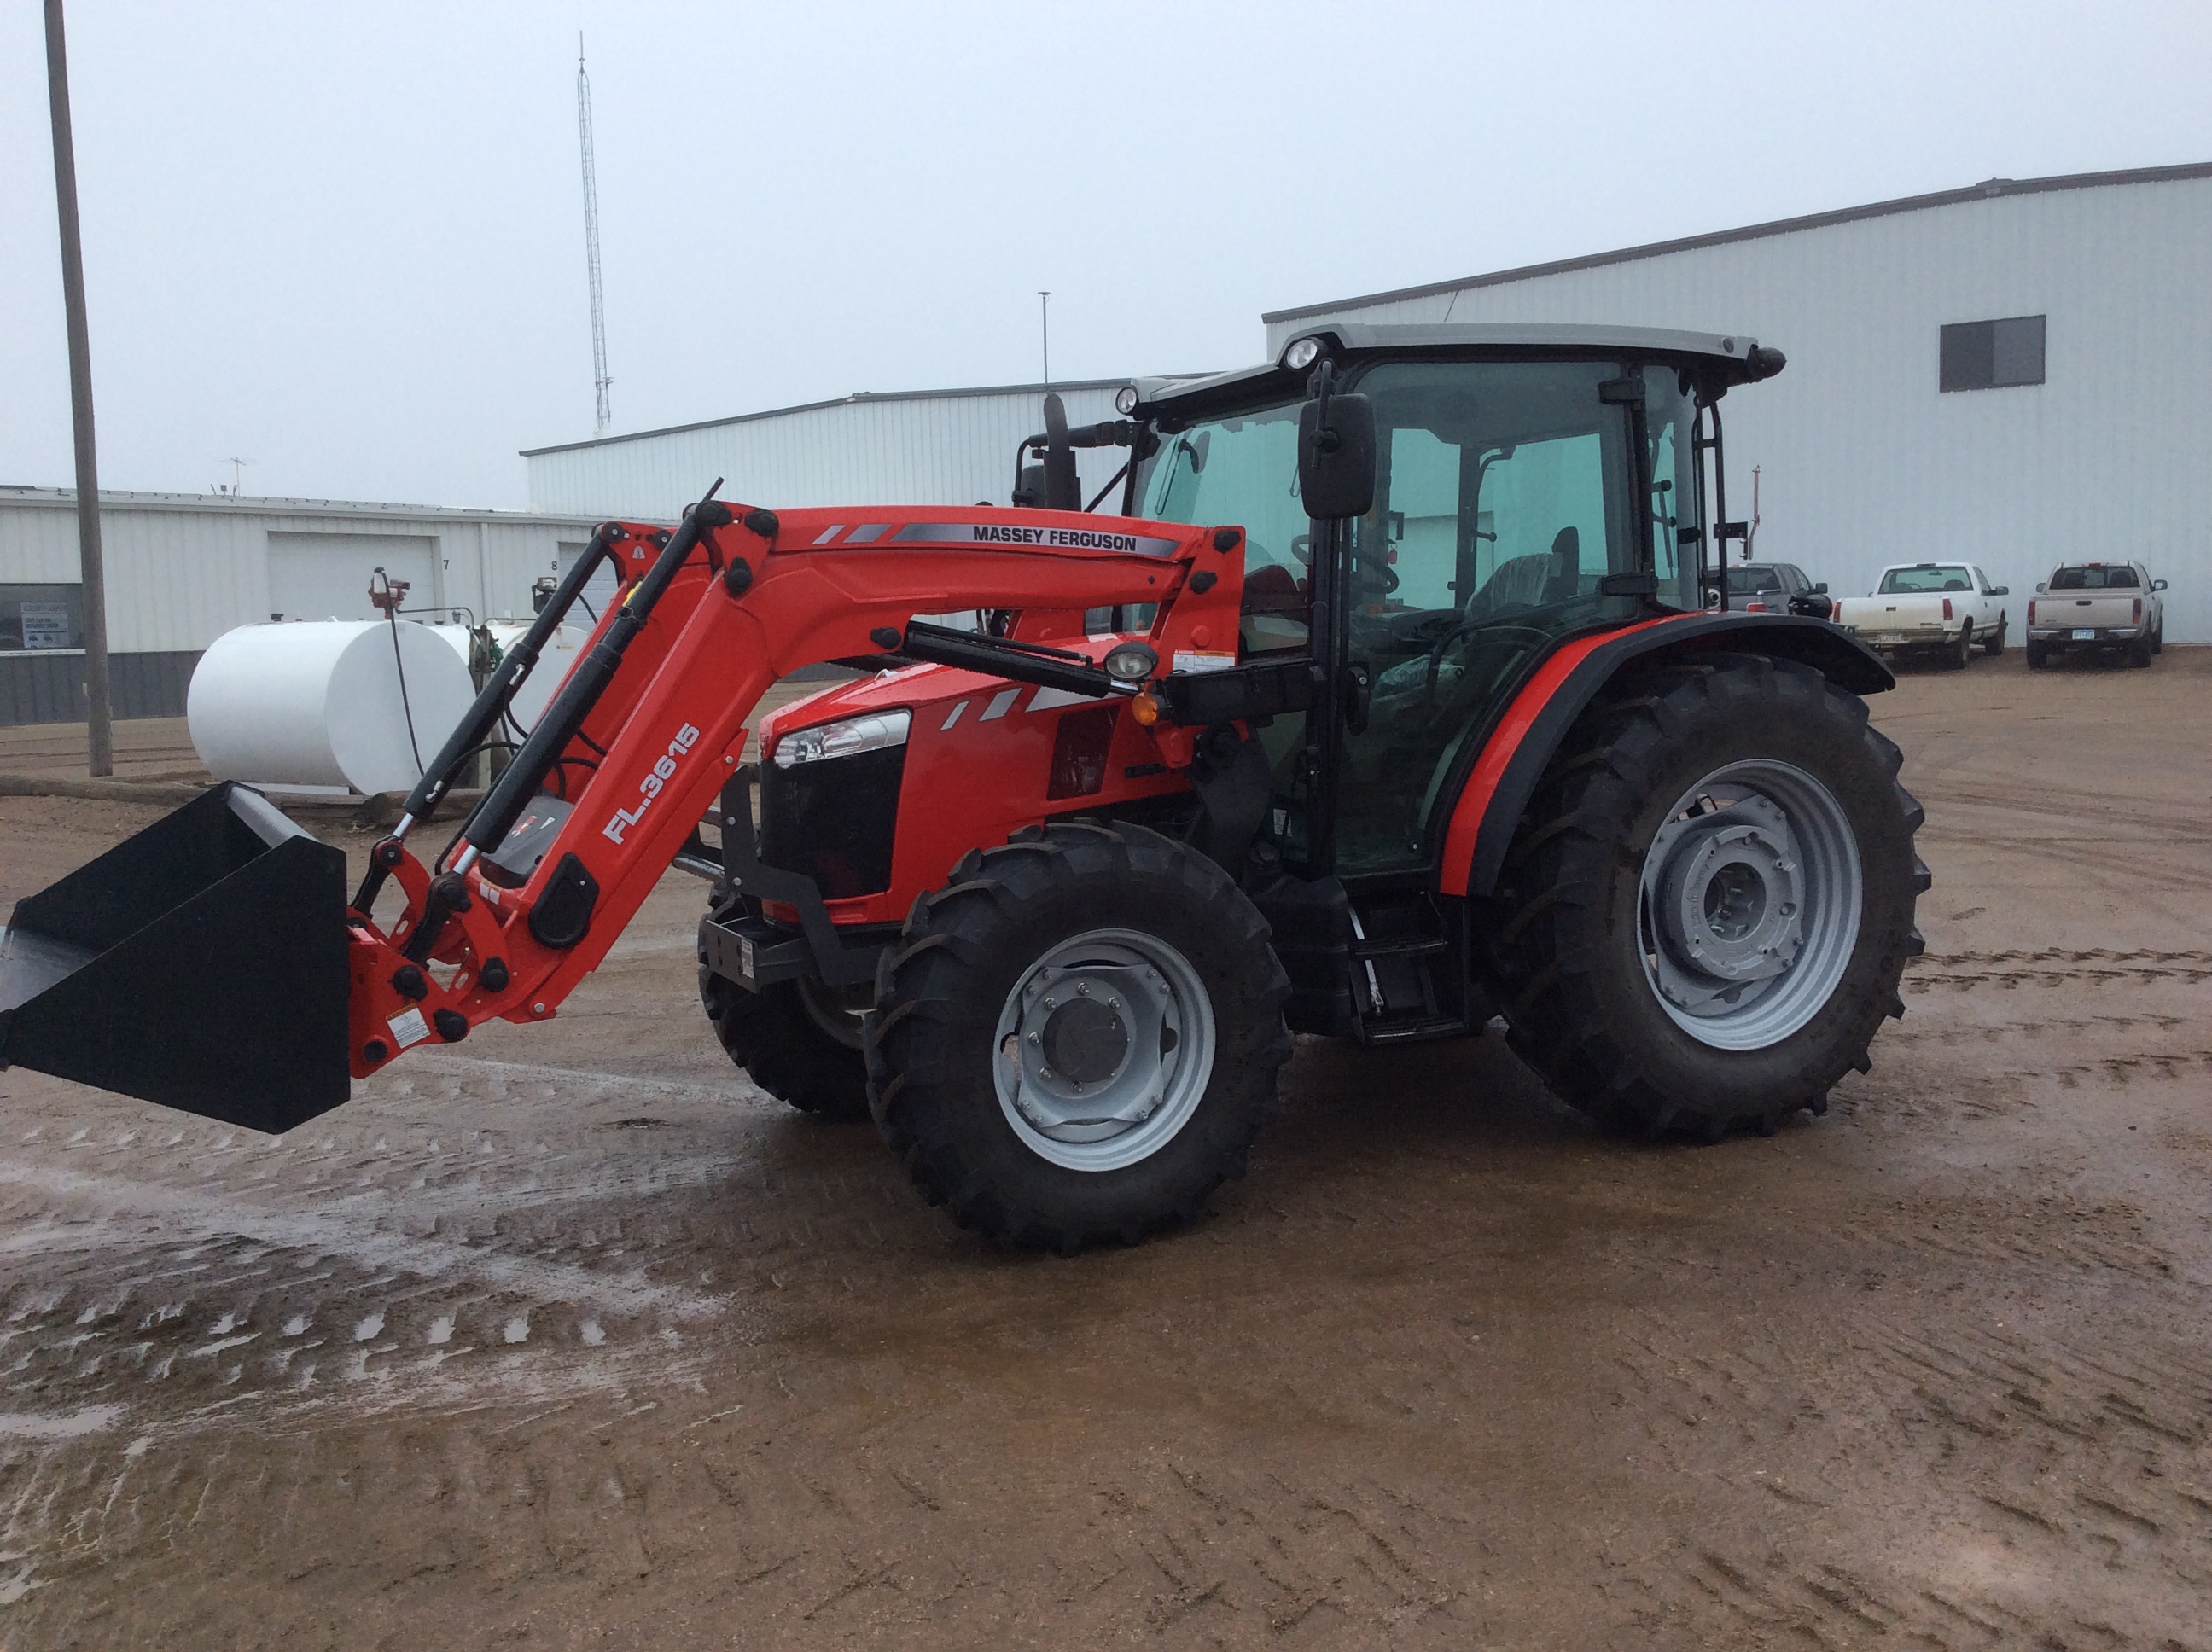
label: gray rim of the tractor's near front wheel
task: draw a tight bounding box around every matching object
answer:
[991,929,1214,1172]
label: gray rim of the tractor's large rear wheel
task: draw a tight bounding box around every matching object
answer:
[1637,759,1865,1050]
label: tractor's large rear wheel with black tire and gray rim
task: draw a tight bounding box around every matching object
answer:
[1491,654,1929,1141]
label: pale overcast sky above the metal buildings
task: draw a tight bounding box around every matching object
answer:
[0,0,2212,506]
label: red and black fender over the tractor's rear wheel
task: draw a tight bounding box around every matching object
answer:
[1440,613,1898,896]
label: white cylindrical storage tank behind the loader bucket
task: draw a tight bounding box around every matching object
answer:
[186,620,475,794]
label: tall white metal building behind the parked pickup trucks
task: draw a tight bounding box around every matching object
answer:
[1266,166,2212,642]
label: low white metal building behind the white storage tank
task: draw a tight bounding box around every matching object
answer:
[0,486,597,725]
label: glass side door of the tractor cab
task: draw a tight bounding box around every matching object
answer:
[1330,360,1697,880]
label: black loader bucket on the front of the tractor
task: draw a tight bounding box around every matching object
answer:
[0,785,350,1132]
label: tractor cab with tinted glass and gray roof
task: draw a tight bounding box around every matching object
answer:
[1124,325,1783,880]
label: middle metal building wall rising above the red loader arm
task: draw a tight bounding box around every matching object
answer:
[524,381,1128,517]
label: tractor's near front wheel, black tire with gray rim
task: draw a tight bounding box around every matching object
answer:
[867,825,1289,1254]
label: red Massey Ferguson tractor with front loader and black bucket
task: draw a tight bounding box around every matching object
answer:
[0,325,1927,1249]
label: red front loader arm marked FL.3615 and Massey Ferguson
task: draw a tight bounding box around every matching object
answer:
[350,506,1243,1077]
